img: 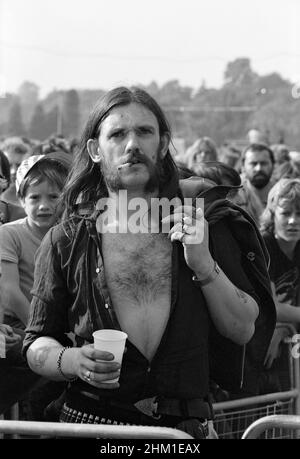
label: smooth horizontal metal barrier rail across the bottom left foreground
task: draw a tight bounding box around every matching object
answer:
[0,420,193,440]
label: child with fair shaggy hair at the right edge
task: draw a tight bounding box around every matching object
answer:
[261,178,300,392]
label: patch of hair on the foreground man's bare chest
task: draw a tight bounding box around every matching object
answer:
[102,234,172,306]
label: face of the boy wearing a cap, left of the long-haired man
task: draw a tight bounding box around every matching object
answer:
[22,180,61,233]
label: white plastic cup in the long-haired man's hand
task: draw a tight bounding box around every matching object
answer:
[93,328,128,383]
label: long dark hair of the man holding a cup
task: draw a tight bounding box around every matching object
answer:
[62,87,178,217]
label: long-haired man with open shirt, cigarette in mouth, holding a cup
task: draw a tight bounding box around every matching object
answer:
[24,87,270,438]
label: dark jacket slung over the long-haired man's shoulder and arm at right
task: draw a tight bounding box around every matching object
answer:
[180,178,276,395]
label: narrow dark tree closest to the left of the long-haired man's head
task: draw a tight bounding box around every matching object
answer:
[62,89,79,137]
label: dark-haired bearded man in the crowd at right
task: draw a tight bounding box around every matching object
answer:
[235,143,274,225]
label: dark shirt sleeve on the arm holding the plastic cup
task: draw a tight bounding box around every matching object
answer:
[23,228,70,355]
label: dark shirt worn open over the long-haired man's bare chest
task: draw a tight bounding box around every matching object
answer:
[24,210,255,402]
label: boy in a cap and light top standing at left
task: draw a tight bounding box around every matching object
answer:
[0,153,72,420]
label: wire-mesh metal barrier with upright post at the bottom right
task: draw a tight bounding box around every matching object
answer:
[213,324,300,439]
